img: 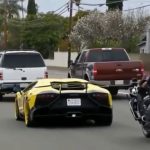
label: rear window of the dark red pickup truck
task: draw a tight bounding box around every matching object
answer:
[86,50,129,62]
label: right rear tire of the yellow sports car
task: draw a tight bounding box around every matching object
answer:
[95,116,113,126]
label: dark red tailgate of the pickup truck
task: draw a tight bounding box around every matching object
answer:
[94,61,144,80]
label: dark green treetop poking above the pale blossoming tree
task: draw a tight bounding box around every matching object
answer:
[106,0,123,11]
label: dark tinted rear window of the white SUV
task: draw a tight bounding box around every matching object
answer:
[2,53,45,68]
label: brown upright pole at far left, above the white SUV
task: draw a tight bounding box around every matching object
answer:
[3,0,8,49]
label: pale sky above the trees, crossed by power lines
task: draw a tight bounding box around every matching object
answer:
[24,0,150,16]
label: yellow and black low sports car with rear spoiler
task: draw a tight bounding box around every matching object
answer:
[15,78,113,127]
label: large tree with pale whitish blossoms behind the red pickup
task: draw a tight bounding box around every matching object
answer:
[70,10,148,52]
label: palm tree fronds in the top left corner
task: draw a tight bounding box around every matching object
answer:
[0,0,25,18]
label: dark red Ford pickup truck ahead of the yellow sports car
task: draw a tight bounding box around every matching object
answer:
[68,48,144,95]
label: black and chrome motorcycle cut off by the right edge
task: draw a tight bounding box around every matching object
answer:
[129,83,150,138]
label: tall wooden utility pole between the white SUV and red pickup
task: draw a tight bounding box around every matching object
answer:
[68,0,73,67]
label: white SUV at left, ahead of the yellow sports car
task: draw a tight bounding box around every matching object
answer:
[0,50,48,100]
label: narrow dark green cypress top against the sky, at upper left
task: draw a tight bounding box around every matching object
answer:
[27,0,38,16]
